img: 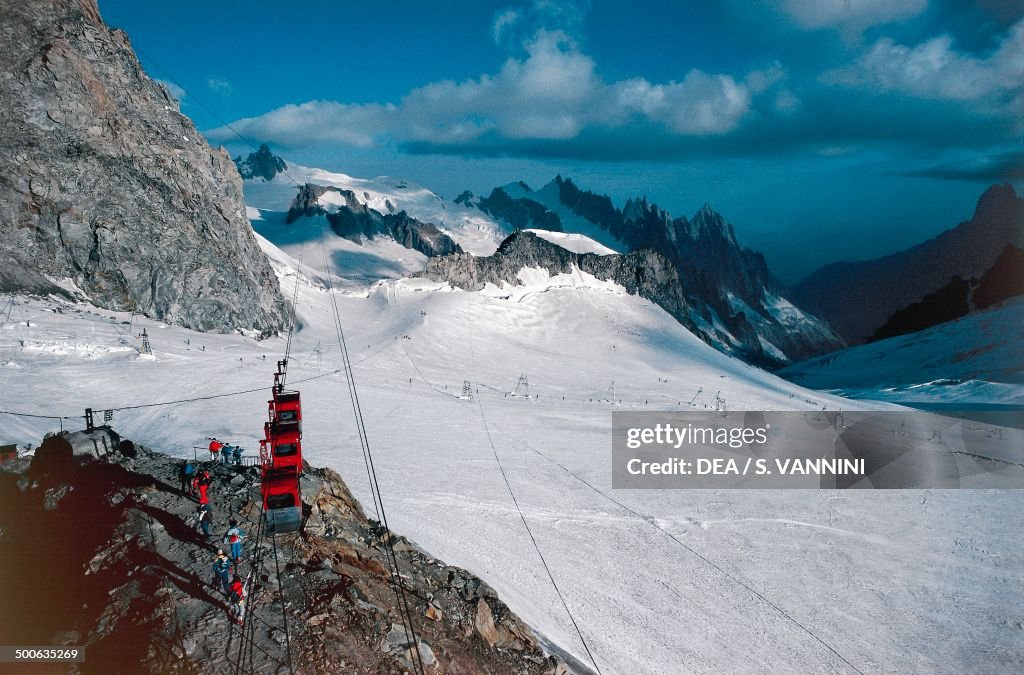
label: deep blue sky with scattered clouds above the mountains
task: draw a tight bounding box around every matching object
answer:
[99,0,1024,281]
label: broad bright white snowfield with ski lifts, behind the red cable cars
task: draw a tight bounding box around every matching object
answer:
[0,221,1024,675]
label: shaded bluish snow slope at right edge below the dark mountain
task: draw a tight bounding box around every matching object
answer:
[780,298,1024,406]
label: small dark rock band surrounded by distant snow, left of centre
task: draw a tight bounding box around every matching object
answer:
[285,183,462,257]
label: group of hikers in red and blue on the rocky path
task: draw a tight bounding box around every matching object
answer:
[180,438,246,625]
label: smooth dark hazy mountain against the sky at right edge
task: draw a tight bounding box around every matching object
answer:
[791,184,1024,344]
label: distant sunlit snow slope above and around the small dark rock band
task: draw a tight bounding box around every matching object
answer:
[244,163,509,255]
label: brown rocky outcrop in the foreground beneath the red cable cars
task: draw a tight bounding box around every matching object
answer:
[0,431,566,675]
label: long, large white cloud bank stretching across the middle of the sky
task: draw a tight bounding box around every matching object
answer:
[210,30,770,146]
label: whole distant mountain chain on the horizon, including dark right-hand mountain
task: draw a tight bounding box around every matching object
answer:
[236,145,1024,368]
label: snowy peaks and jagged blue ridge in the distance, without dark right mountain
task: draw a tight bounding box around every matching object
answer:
[245,156,842,368]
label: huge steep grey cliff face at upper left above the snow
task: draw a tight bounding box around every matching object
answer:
[0,0,287,334]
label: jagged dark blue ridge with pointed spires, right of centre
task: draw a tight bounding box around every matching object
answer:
[456,176,843,367]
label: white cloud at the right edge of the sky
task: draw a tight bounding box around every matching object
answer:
[823,20,1024,114]
